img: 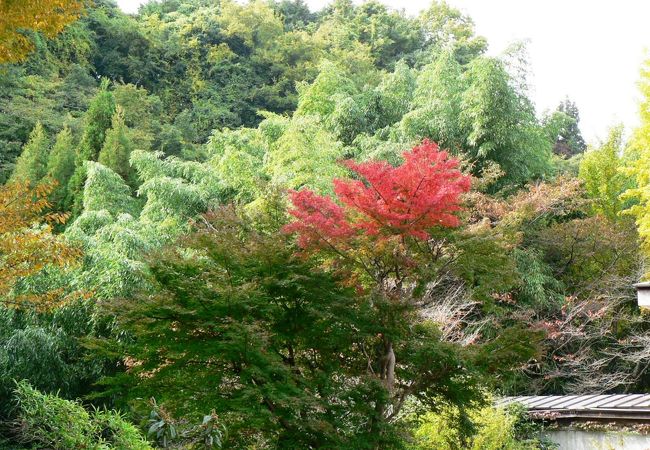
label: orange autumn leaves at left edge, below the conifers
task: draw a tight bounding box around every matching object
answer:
[0,183,80,309]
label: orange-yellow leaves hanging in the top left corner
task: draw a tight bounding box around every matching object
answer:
[0,0,84,64]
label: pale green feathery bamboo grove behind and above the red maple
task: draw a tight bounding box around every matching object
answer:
[284,48,555,188]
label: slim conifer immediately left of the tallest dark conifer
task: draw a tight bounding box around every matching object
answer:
[47,125,75,209]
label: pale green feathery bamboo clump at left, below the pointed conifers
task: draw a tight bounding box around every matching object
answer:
[66,150,220,298]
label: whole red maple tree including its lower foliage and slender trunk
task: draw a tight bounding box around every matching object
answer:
[284,140,470,400]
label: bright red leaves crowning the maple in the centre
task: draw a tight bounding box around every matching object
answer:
[284,140,470,248]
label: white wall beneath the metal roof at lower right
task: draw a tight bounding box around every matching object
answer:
[545,429,650,450]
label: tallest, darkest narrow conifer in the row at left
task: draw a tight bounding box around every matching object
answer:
[66,80,115,216]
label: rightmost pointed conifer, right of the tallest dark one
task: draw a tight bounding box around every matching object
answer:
[99,106,136,187]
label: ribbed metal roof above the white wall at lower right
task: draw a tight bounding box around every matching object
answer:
[497,394,650,423]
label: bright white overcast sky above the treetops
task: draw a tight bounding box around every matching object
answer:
[117,0,650,142]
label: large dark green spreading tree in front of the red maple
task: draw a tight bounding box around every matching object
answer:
[98,208,484,448]
